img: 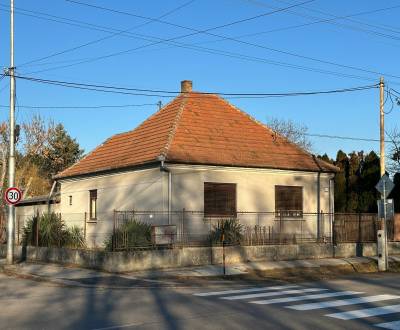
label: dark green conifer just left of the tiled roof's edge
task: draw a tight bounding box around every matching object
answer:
[42,124,83,177]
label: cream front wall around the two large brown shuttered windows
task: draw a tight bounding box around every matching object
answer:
[169,165,333,242]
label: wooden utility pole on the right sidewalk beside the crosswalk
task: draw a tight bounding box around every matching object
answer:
[379,77,388,271]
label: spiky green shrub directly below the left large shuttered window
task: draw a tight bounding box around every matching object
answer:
[210,219,243,244]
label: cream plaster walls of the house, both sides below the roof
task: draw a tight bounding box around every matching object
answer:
[60,164,334,247]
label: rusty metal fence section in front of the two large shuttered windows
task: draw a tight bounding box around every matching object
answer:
[112,210,333,251]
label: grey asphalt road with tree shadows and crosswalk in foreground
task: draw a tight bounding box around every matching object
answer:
[0,274,400,329]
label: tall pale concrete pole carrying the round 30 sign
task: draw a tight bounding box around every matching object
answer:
[7,0,15,264]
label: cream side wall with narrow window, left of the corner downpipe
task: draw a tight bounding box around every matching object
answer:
[60,168,162,246]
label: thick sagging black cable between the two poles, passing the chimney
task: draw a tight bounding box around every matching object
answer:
[10,75,378,98]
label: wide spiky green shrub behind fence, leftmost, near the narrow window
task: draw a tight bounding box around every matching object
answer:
[22,213,85,248]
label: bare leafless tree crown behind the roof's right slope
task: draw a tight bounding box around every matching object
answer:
[267,118,312,151]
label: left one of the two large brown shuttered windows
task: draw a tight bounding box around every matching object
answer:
[204,182,236,217]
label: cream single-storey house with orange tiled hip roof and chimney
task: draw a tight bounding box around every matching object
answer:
[18,81,337,245]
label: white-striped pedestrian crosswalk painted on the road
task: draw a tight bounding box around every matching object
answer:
[193,284,400,330]
